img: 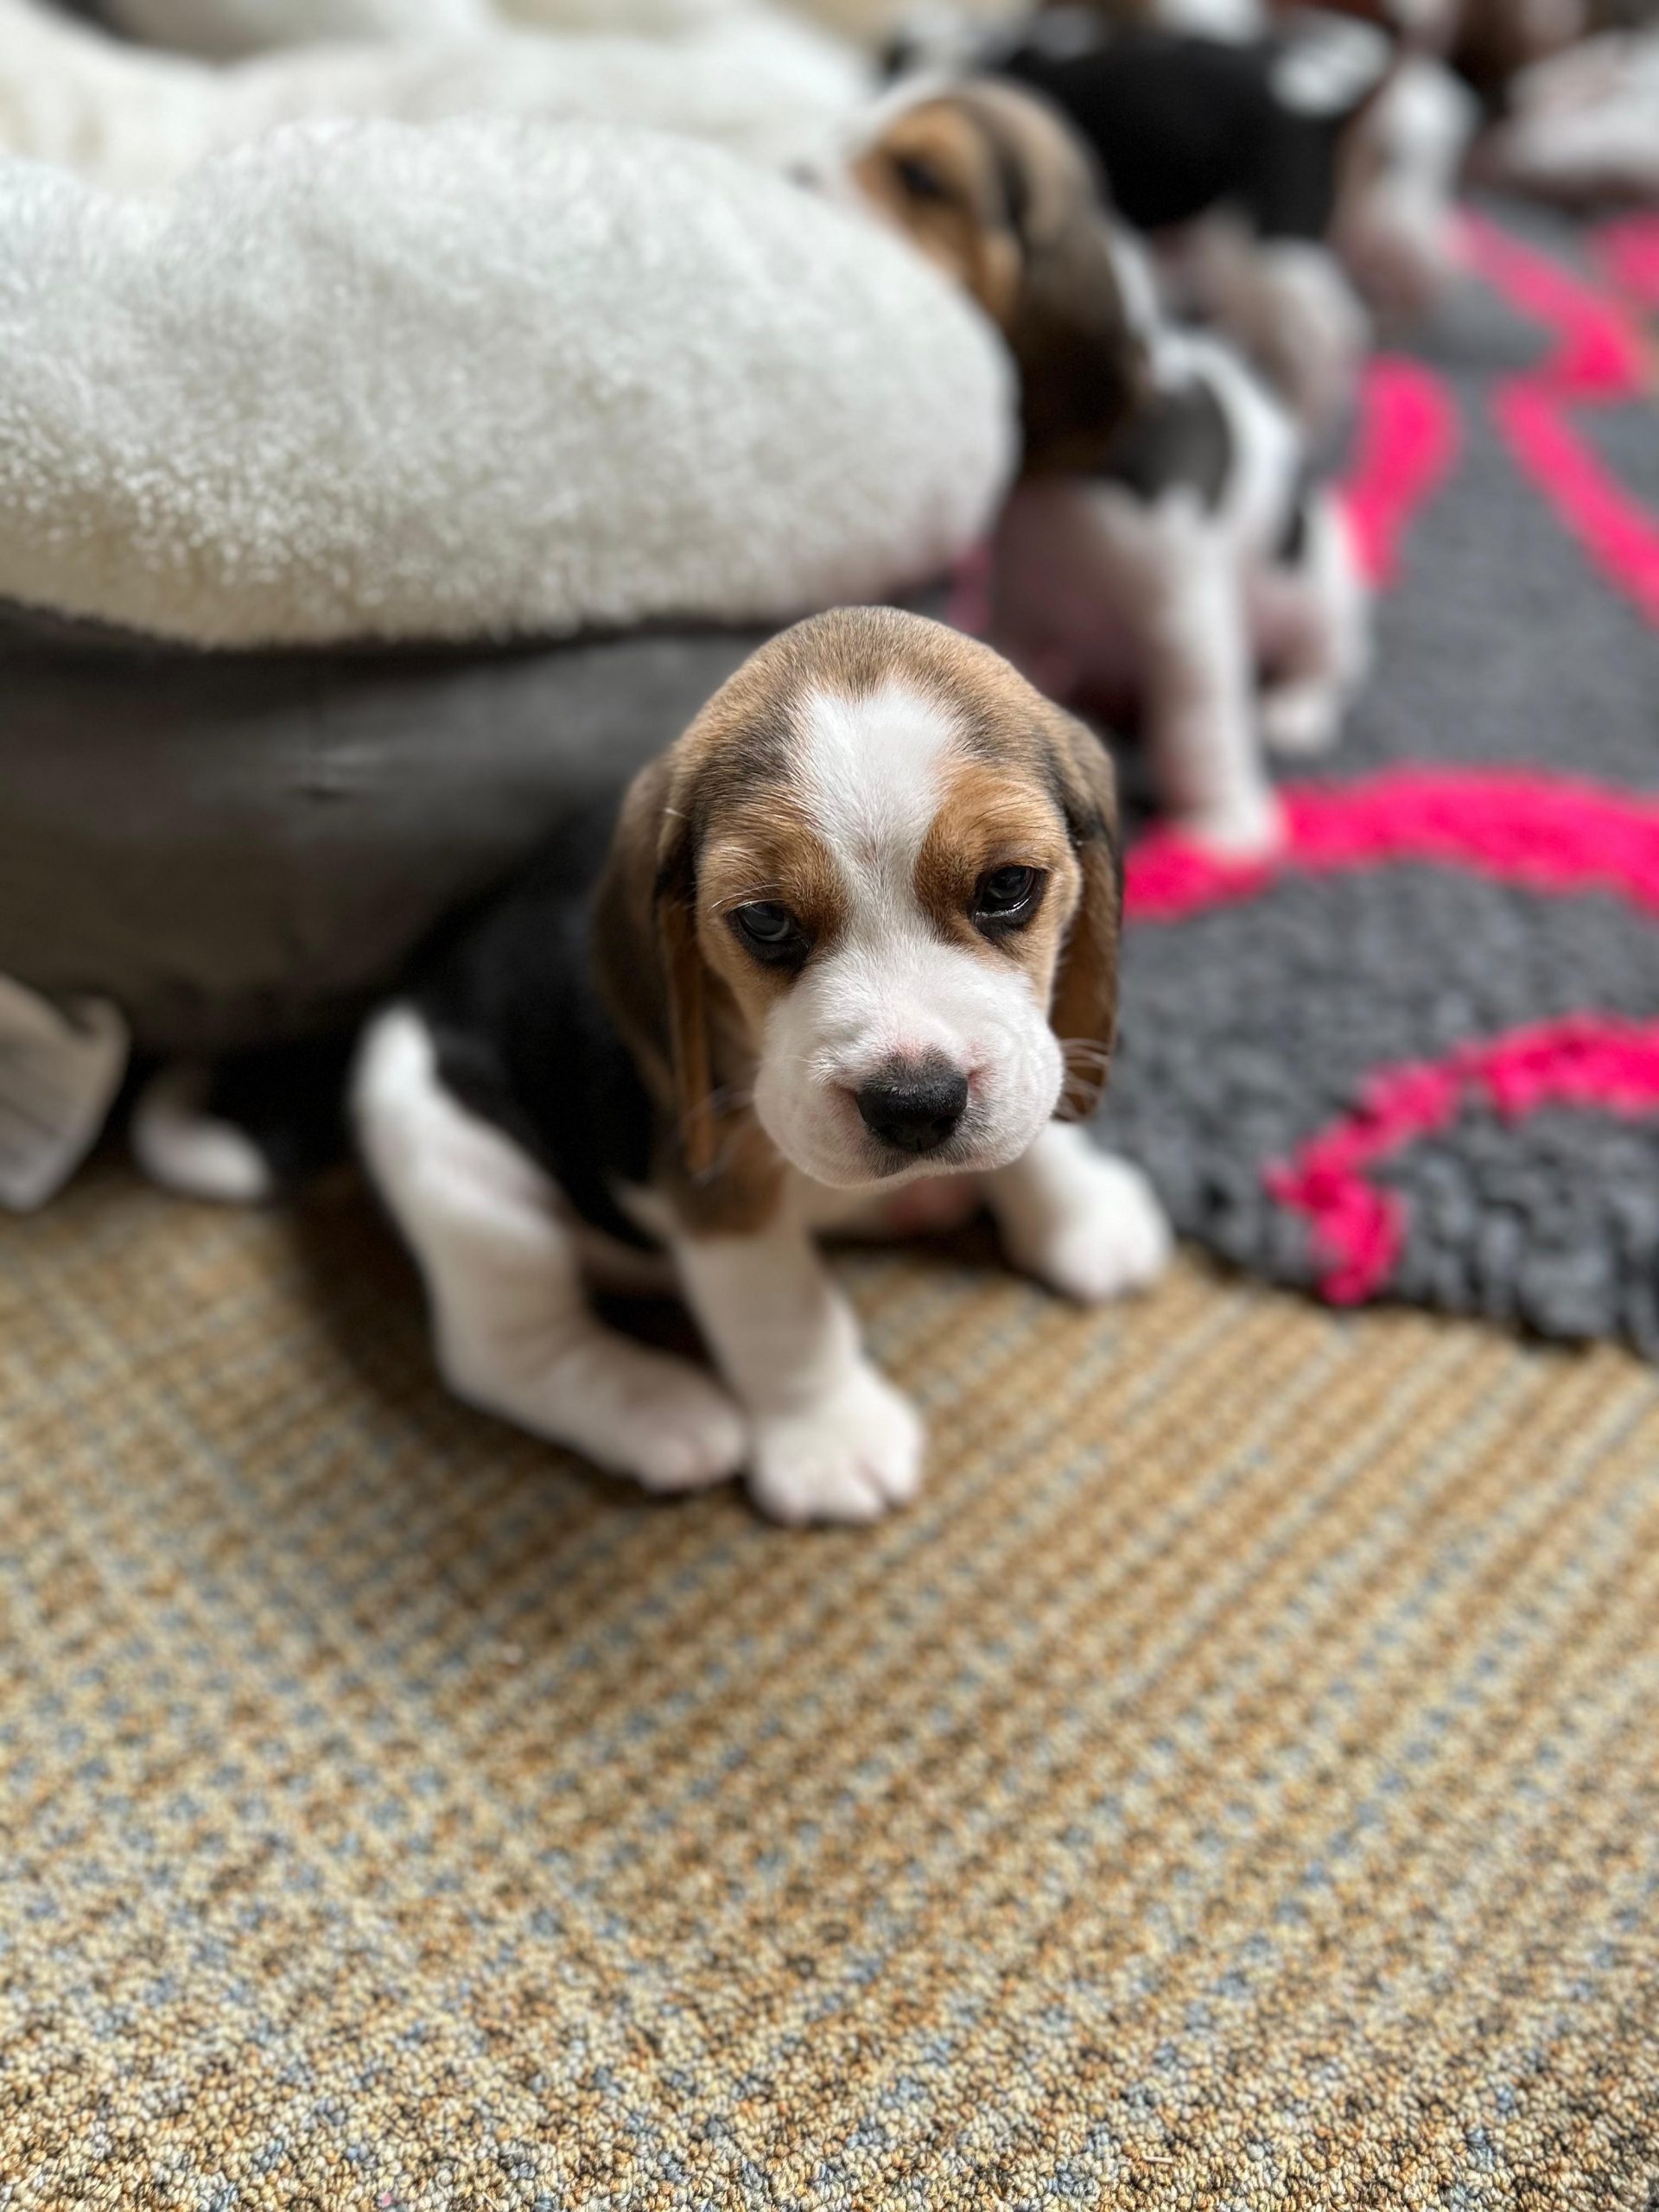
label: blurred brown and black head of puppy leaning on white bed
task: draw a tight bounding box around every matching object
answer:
[854,82,1146,471]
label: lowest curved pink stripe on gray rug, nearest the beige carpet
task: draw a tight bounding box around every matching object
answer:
[1263,1013,1659,1305]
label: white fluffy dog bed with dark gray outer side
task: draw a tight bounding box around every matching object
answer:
[0,0,1013,1051]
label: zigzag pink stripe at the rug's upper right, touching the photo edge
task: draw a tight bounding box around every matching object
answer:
[1465,217,1659,621]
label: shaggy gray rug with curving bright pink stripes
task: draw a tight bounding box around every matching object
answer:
[1102,210,1659,1356]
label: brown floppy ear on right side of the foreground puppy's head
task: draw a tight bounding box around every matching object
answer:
[1048,710,1123,1122]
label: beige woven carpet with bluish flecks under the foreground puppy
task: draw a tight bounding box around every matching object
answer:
[0,1170,1659,2212]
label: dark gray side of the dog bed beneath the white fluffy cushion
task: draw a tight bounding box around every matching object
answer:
[0,608,779,1053]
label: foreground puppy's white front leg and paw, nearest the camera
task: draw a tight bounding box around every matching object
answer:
[675,1219,923,1522]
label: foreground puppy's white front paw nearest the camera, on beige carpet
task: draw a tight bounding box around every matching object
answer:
[750,1360,923,1524]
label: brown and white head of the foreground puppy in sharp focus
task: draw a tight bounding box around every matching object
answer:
[600,608,1122,1188]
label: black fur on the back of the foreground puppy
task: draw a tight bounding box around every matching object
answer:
[411,798,655,1245]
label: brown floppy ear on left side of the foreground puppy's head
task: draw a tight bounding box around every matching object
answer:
[595,752,715,1177]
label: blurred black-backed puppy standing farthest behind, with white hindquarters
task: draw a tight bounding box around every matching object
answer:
[898,0,1473,429]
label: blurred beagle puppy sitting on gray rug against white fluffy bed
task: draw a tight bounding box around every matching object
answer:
[854,82,1370,854]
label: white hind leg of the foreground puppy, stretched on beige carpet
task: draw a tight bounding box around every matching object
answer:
[352,1007,747,1491]
